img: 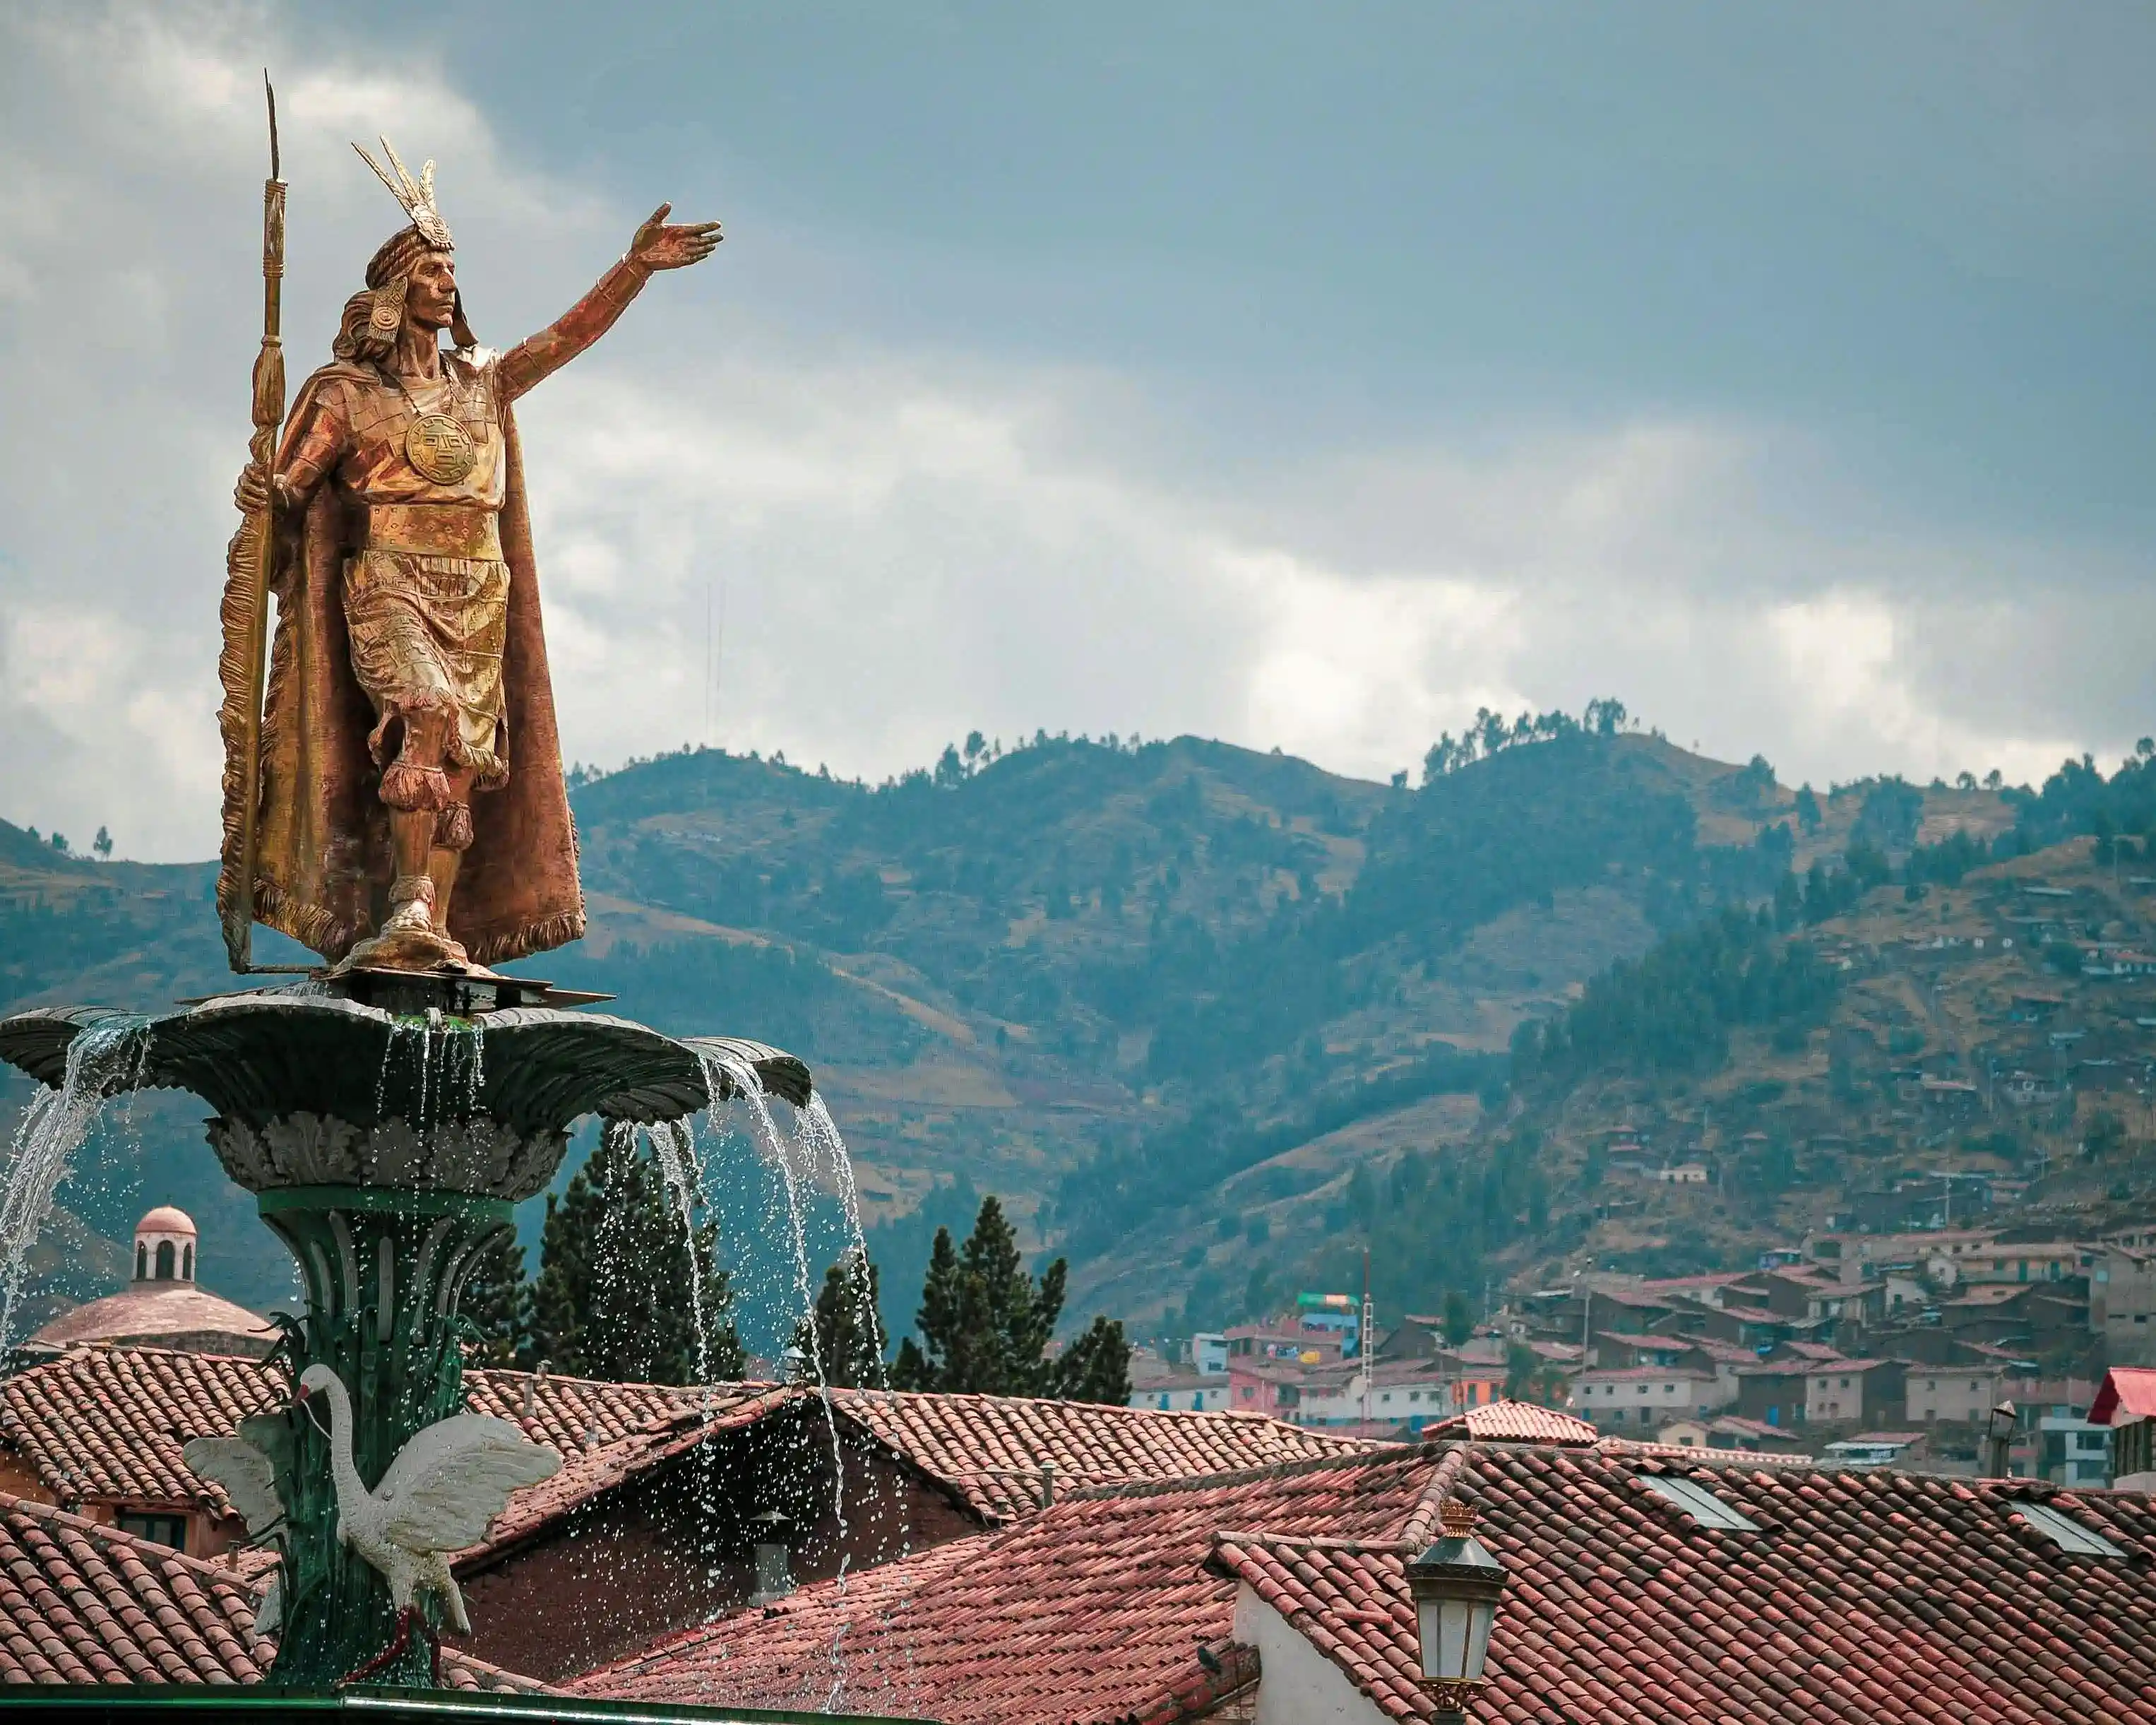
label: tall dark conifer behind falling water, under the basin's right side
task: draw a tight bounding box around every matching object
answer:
[530,1123,742,1385]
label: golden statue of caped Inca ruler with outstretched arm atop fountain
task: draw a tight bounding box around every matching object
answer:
[218,140,720,971]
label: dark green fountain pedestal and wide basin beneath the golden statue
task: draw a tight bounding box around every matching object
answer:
[0,977,811,1688]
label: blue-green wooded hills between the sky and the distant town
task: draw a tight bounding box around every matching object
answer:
[0,720,2124,1326]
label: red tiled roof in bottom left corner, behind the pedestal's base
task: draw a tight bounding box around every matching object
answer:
[0,1494,550,1695]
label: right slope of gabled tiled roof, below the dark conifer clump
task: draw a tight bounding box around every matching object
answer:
[832,1389,1369,1520]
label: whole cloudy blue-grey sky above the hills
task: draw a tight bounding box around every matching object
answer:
[0,0,2156,858]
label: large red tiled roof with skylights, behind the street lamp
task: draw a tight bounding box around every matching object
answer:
[578,1445,2156,1725]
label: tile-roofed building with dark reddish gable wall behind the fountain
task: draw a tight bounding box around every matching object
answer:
[0,1348,1367,1680]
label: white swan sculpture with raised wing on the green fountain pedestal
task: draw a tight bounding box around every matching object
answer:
[299,1365,561,1637]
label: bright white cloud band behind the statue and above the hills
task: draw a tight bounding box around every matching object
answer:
[0,4,2156,858]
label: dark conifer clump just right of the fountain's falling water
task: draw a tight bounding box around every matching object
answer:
[891,1197,1130,1399]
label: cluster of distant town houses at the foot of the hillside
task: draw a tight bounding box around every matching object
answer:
[1132,1207,2156,1486]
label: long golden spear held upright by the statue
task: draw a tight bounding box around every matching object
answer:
[218,69,285,973]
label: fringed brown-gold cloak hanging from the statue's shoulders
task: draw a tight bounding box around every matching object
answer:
[218,362,584,964]
